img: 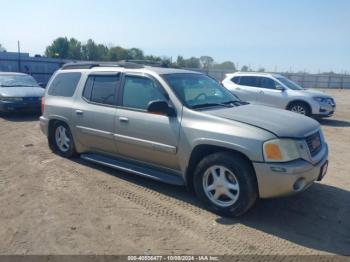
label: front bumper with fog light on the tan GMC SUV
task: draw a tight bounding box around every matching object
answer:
[253,144,328,198]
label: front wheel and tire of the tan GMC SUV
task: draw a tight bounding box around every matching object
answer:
[193,152,258,217]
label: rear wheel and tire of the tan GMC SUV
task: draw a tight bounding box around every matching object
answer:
[48,121,77,158]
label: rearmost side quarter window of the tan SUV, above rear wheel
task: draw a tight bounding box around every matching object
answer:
[48,72,81,97]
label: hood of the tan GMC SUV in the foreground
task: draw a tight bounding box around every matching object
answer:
[206,104,320,138]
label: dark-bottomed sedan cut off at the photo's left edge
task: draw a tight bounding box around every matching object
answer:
[0,72,45,112]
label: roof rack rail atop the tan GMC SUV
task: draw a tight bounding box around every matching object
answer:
[61,61,144,70]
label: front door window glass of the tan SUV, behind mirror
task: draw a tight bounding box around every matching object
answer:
[122,76,166,110]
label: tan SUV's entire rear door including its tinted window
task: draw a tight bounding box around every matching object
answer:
[73,74,120,153]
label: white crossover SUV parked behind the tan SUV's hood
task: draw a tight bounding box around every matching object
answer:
[222,72,336,117]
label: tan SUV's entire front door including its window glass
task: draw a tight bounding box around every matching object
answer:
[115,74,180,169]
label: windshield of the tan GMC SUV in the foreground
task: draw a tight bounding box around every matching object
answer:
[162,73,241,109]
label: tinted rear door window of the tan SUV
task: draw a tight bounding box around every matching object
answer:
[83,75,120,105]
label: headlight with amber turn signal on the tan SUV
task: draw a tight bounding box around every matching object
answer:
[263,139,300,162]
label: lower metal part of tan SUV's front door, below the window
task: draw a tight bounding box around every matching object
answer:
[114,109,180,169]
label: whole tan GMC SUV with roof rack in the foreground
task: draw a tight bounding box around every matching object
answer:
[40,62,328,216]
